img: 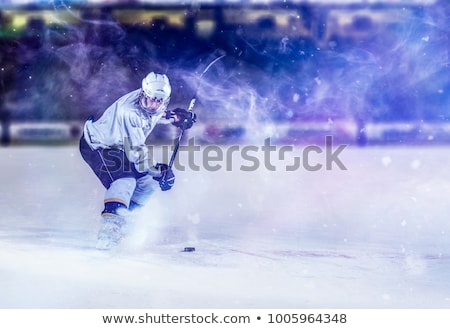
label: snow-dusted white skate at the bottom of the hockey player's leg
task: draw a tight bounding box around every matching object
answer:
[96,216,125,250]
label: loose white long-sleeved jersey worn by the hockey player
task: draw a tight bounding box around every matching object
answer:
[84,89,170,175]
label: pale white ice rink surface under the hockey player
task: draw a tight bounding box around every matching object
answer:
[0,146,450,308]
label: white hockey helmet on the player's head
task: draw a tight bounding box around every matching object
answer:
[141,72,172,113]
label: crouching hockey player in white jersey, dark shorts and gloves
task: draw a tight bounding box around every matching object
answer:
[80,72,196,249]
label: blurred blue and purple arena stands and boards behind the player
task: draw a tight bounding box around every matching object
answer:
[0,0,450,146]
